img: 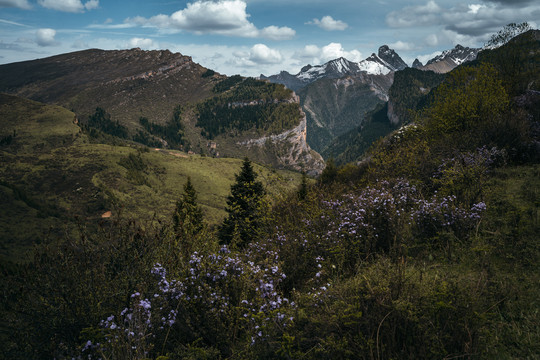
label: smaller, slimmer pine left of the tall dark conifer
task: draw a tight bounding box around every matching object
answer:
[173,177,204,249]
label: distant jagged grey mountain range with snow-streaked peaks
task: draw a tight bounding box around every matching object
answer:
[260,45,480,155]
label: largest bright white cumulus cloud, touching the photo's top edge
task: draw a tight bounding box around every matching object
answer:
[125,0,296,40]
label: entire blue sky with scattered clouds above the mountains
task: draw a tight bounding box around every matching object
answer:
[0,0,540,76]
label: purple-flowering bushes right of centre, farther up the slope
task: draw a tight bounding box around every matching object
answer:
[319,179,488,252]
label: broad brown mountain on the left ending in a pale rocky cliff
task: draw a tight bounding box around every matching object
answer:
[0,49,324,175]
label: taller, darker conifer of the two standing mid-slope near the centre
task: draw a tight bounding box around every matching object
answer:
[218,157,266,247]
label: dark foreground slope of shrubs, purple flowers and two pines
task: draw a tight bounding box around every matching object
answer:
[0,27,540,360]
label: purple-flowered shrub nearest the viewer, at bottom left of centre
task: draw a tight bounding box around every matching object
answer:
[86,246,296,350]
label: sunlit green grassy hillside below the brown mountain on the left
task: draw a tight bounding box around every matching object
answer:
[0,95,300,260]
